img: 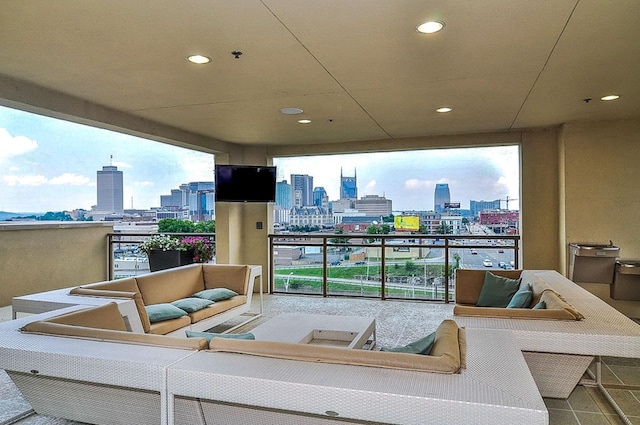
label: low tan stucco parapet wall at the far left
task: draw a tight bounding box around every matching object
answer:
[0,223,113,306]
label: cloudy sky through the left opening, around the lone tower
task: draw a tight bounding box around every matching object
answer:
[0,106,214,212]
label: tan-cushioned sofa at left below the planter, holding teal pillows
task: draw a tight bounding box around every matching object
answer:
[70,264,255,336]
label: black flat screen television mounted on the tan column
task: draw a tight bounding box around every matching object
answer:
[215,165,276,202]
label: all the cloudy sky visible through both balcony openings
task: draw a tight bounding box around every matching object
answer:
[0,106,519,212]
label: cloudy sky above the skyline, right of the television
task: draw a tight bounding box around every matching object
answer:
[274,145,520,211]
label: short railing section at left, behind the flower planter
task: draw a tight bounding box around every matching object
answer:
[108,232,216,280]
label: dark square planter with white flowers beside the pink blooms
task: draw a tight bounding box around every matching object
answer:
[138,234,193,272]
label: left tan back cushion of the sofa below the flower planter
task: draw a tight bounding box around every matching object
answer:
[136,264,205,305]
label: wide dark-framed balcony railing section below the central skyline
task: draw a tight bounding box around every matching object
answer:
[269,234,520,302]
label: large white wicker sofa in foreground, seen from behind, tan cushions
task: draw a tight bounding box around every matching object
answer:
[0,303,548,425]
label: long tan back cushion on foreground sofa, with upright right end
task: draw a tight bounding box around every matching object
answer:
[209,320,461,373]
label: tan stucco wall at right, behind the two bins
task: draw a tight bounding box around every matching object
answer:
[560,119,640,270]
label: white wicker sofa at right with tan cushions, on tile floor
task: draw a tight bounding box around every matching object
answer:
[454,269,640,398]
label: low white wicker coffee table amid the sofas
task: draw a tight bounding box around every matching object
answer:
[251,313,376,349]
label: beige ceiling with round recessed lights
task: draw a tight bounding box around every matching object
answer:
[0,0,640,150]
